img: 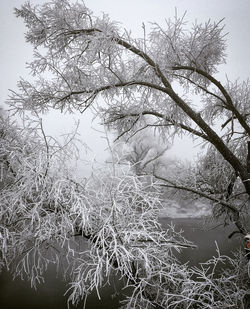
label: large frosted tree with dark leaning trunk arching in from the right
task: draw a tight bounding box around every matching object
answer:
[10,0,250,233]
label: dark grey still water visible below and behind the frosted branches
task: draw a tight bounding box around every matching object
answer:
[0,218,241,309]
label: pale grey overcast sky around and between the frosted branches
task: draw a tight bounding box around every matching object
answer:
[0,0,250,166]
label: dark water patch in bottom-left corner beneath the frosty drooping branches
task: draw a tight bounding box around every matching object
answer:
[0,266,123,309]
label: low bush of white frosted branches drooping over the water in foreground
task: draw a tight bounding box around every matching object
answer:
[0,111,248,309]
